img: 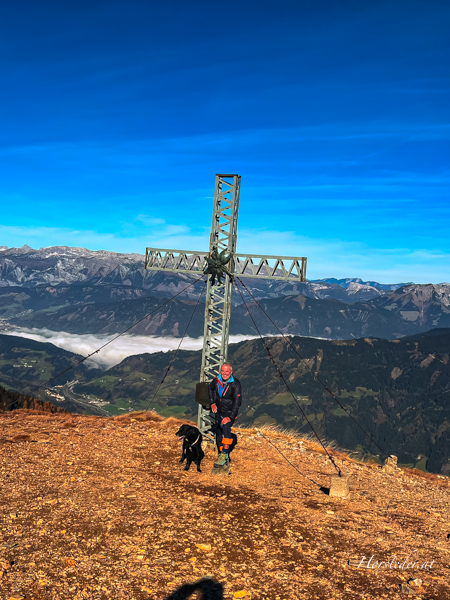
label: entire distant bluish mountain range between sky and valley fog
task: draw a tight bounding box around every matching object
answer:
[0,246,450,339]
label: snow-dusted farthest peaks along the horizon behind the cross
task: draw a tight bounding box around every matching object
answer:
[0,245,411,302]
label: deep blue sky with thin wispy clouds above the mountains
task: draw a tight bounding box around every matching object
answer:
[0,0,450,283]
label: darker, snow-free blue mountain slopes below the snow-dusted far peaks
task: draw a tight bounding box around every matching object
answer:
[0,282,450,339]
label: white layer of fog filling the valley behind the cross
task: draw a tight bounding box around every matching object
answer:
[8,328,255,369]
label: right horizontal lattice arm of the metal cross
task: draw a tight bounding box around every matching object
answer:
[232,253,306,281]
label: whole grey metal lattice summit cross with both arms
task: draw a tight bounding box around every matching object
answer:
[145,175,306,439]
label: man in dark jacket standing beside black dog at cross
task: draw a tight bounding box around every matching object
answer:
[208,363,242,467]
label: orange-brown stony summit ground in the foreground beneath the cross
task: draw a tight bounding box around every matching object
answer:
[0,410,450,600]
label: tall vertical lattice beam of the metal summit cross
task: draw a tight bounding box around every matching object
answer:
[198,175,241,437]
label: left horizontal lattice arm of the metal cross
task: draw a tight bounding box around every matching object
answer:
[145,248,209,273]
